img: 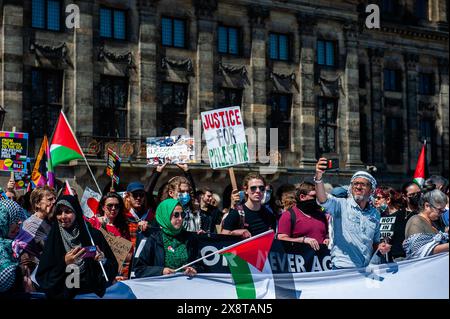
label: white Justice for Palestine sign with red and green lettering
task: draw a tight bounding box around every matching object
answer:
[202,106,249,168]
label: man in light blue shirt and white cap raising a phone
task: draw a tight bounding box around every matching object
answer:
[314,157,391,269]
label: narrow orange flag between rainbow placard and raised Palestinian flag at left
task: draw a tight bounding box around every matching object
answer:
[31,135,55,187]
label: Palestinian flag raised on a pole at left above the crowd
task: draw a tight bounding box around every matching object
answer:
[50,111,84,167]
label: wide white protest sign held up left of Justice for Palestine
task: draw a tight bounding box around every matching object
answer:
[147,135,195,165]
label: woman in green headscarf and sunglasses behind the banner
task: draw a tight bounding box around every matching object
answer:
[134,198,199,278]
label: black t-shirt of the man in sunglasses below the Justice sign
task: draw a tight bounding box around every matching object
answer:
[223,205,276,236]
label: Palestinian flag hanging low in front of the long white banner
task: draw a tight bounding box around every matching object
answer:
[220,231,275,299]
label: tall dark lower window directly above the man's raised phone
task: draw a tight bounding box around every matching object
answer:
[316,96,339,156]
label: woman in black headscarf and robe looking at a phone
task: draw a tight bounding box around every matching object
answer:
[36,195,118,299]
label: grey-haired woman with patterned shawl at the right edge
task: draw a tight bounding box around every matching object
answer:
[403,184,448,259]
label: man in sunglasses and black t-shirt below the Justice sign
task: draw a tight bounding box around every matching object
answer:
[221,173,276,238]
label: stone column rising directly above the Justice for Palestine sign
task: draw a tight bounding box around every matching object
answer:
[193,0,217,119]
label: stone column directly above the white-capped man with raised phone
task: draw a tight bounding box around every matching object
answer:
[339,24,362,170]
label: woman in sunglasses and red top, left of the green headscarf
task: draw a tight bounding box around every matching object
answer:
[89,192,133,280]
